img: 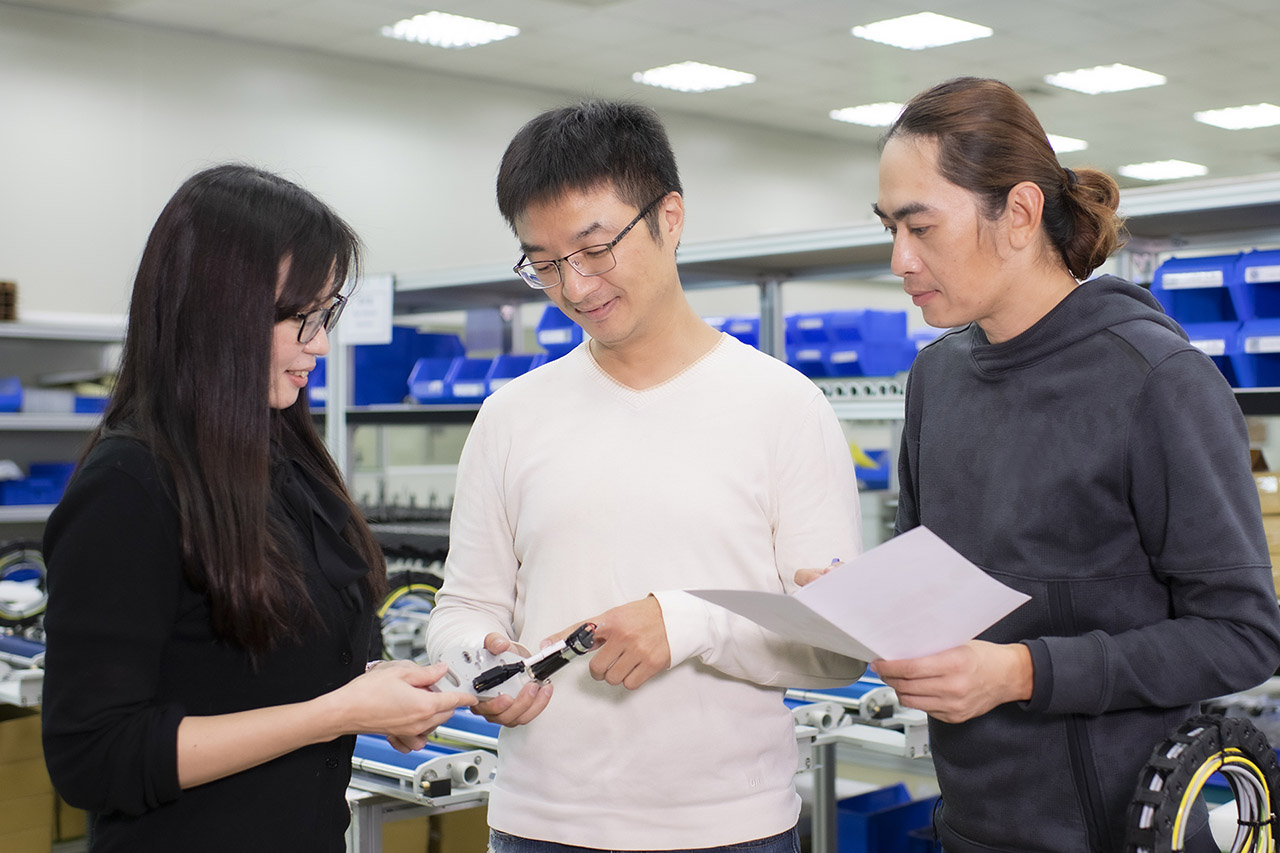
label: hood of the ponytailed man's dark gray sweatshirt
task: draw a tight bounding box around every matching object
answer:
[960,275,1187,373]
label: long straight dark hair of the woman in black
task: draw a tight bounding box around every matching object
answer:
[95,164,387,656]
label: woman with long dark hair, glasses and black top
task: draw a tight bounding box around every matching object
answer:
[44,165,474,853]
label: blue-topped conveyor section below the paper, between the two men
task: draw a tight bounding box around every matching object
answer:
[786,675,929,758]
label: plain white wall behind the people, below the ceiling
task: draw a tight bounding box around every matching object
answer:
[0,6,876,314]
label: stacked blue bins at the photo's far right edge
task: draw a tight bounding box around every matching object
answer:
[1230,250,1280,388]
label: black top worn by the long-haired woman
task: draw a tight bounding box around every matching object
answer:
[44,438,374,853]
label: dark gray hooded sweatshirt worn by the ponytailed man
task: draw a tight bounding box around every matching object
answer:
[897,277,1280,853]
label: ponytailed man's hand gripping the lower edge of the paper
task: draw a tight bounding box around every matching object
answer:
[872,640,1034,722]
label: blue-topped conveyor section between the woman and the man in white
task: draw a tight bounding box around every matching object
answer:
[351,735,498,807]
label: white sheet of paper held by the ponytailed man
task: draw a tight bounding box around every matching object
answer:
[689,528,1030,661]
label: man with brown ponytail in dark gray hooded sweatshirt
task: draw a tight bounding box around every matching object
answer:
[873,78,1280,853]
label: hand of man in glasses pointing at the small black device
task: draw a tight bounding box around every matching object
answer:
[544,596,671,690]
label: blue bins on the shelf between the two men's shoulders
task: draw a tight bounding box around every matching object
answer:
[786,303,916,377]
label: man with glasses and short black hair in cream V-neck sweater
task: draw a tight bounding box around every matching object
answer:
[428,101,863,853]
